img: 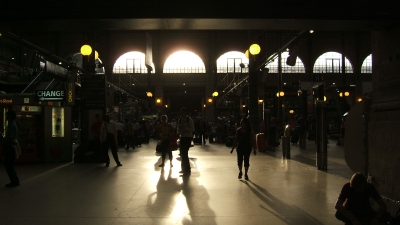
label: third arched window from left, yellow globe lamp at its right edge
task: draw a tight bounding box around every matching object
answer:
[217,51,249,73]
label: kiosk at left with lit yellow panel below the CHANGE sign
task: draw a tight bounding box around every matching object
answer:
[0,90,72,162]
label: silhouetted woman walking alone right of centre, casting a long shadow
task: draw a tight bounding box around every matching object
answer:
[231,118,257,180]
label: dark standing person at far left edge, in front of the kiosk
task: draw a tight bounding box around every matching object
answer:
[2,110,21,188]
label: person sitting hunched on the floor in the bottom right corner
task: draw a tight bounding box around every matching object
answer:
[335,173,391,225]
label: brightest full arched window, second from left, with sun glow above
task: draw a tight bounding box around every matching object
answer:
[163,51,206,73]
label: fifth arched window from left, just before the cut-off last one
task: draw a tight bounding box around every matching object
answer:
[313,52,353,73]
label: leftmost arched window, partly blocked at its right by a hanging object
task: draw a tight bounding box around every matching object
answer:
[113,51,154,73]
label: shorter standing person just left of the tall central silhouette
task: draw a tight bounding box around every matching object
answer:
[158,115,174,167]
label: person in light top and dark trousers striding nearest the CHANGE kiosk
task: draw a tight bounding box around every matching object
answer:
[100,115,122,166]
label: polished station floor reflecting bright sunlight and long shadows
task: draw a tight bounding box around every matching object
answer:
[0,138,353,225]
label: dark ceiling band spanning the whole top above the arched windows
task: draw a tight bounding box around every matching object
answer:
[0,0,400,31]
